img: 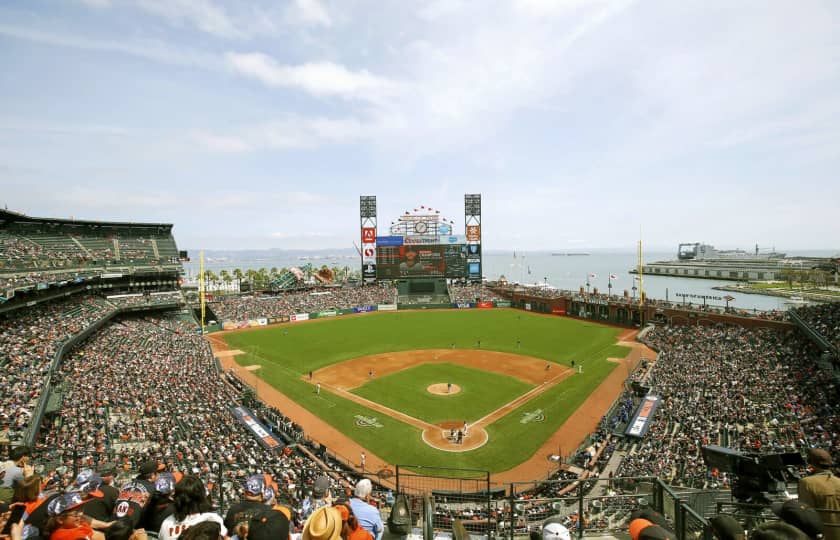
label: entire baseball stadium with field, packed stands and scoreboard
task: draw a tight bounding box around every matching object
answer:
[0,194,840,540]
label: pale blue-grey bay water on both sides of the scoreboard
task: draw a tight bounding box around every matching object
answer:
[185,250,831,310]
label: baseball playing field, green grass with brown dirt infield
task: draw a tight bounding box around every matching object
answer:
[214,309,630,472]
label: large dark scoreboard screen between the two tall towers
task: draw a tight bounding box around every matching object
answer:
[376,244,467,279]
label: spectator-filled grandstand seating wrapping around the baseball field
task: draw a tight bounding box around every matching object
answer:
[0,208,840,539]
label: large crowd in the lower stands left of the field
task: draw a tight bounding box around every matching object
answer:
[29,315,368,528]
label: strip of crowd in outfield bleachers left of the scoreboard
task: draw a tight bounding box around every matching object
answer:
[209,283,396,321]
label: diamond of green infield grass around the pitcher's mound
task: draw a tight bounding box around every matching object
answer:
[353,363,533,424]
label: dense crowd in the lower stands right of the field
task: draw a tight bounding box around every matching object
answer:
[617,326,840,488]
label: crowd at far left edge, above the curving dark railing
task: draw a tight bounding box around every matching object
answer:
[0,295,113,441]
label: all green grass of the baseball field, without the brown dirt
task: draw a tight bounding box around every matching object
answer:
[224,309,628,472]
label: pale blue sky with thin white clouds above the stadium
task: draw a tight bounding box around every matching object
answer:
[0,0,840,251]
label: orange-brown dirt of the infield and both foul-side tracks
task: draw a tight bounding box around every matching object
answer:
[208,330,656,483]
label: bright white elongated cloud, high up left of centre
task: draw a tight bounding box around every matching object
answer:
[225,53,393,100]
